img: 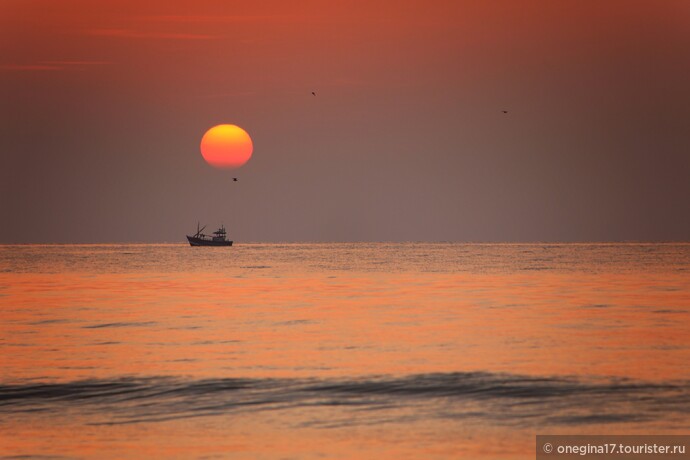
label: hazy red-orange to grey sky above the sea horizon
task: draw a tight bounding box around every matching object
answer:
[0,0,690,243]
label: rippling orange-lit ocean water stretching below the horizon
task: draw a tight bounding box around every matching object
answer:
[0,243,690,459]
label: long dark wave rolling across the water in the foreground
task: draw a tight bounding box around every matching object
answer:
[0,372,690,427]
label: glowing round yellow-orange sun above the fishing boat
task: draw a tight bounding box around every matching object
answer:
[200,125,254,169]
